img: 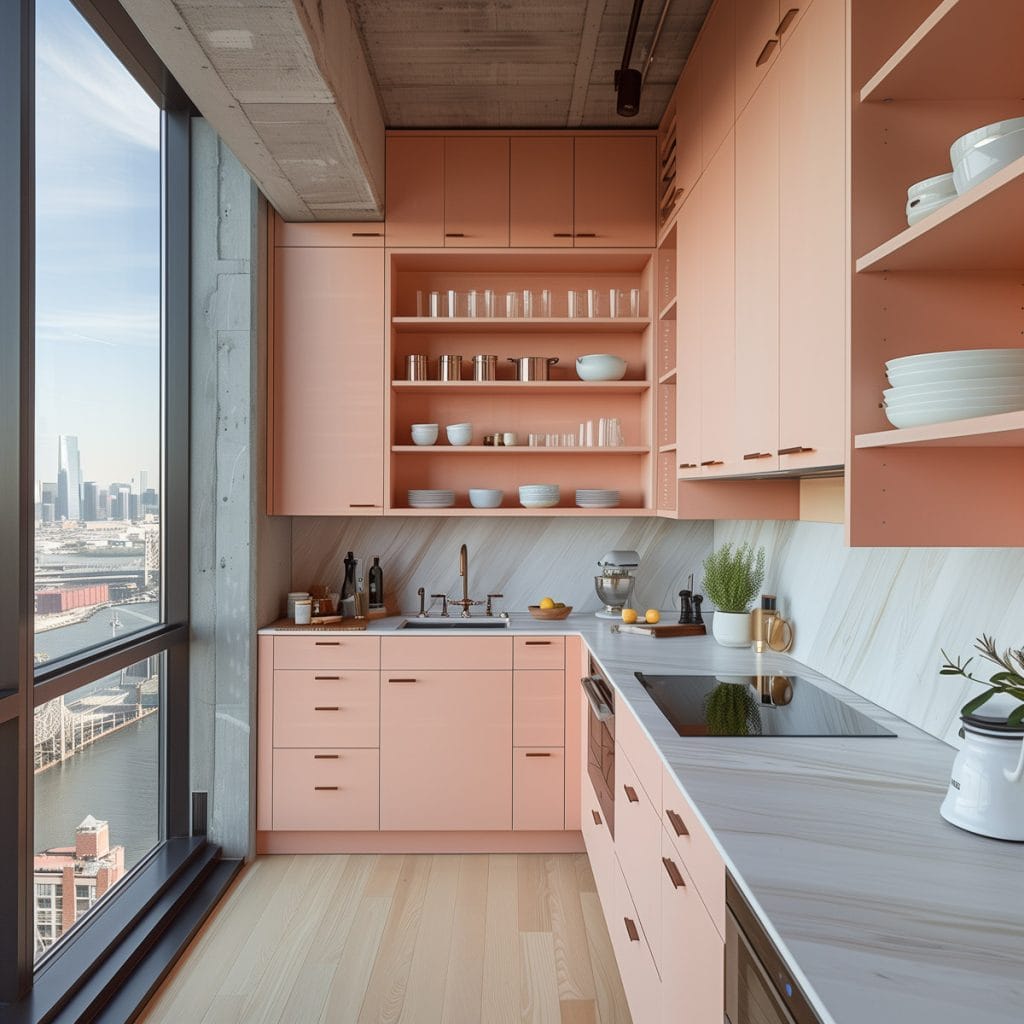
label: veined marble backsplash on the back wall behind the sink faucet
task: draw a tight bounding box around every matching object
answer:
[292,517,713,613]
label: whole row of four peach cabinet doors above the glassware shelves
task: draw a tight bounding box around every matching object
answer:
[386,132,656,249]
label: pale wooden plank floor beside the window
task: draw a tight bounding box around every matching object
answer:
[140,854,630,1024]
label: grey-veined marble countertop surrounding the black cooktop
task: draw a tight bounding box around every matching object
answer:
[261,613,1024,1024]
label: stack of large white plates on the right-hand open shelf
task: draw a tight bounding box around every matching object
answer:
[885,348,1024,428]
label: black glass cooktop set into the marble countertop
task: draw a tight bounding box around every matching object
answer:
[636,672,895,736]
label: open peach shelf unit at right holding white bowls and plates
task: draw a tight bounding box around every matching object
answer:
[848,0,1024,547]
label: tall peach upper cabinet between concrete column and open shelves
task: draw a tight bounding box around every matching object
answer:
[267,236,385,515]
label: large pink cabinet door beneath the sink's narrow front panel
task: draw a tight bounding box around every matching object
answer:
[381,667,512,830]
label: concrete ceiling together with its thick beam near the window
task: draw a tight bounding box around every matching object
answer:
[121,0,711,220]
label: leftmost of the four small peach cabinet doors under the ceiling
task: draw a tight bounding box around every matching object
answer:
[384,135,444,248]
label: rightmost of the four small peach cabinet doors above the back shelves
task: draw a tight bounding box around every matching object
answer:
[573,135,657,249]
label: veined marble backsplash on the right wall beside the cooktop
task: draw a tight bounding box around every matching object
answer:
[715,522,1024,745]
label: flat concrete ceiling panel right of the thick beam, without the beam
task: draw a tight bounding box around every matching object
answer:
[348,0,711,128]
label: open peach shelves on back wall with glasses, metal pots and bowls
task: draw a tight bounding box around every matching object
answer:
[385,250,656,516]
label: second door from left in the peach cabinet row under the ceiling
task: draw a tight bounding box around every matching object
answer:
[444,135,509,249]
